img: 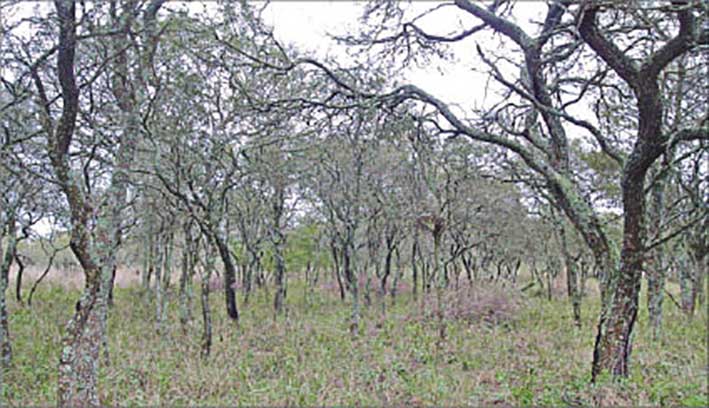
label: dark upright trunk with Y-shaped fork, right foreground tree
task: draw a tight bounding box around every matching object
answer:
[579,3,706,379]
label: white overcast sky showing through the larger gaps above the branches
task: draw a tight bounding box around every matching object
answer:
[263,1,546,116]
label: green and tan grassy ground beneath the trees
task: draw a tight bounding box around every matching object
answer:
[0,283,709,406]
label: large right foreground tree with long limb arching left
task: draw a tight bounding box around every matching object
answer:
[312,0,707,379]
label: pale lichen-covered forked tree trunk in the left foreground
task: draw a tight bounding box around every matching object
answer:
[30,0,162,406]
